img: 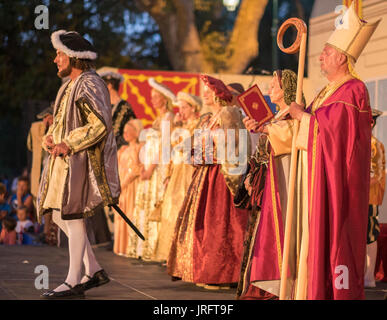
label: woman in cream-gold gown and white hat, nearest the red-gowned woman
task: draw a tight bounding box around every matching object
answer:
[156,91,202,262]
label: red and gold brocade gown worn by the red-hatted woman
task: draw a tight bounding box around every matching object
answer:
[167,107,250,284]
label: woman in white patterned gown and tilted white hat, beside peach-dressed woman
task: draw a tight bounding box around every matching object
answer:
[128,78,176,261]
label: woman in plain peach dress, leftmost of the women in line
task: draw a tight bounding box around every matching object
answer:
[113,119,143,256]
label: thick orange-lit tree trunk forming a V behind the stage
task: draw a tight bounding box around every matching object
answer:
[136,0,268,73]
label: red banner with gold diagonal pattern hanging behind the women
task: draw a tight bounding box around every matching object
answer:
[118,69,200,127]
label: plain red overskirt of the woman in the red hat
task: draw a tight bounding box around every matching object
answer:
[192,165,248,284]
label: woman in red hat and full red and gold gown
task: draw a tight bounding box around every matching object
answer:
[168,75,250,289]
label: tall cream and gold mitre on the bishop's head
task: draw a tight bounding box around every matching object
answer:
[327,2,382,62]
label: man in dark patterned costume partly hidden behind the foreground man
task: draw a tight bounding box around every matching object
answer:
[99,71,136,149]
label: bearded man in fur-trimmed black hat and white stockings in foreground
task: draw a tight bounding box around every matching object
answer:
[37,30,120,299]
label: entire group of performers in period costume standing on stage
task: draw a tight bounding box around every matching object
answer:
[30,3,385,299]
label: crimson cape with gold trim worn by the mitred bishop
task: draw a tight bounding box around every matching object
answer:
[308,79,372,300]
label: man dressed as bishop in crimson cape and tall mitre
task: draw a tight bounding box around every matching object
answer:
[290,5,380,300]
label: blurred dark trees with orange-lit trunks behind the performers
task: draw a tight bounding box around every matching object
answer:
[0,0,314,176]
